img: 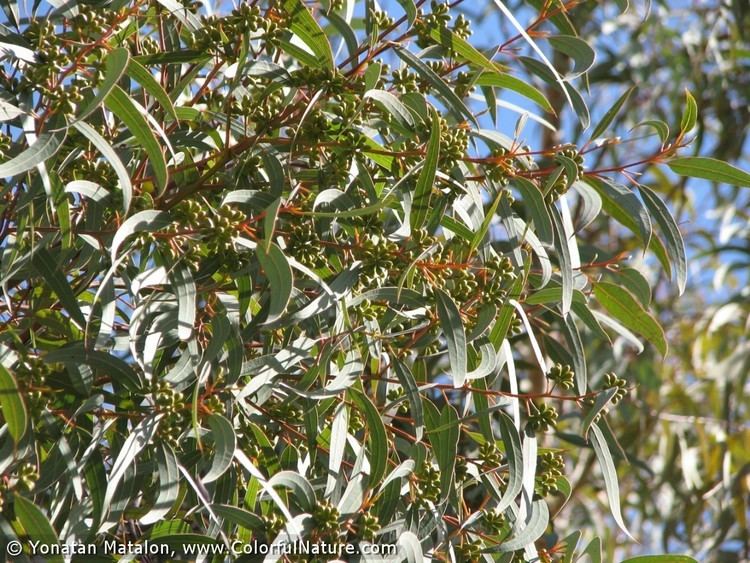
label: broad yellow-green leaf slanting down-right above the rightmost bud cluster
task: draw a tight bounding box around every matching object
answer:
[594,282,667,356]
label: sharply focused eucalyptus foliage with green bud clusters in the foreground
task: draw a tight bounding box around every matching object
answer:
[0,0,750,562]
